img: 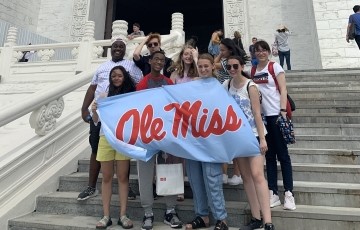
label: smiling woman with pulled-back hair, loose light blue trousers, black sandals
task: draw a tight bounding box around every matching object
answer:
[185,54,228,230]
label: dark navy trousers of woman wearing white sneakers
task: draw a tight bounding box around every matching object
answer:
[265,116,293,194]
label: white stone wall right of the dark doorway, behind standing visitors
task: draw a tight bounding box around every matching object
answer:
[244,0,321,70]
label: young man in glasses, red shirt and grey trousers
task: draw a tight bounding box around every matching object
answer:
[136,51,182,230]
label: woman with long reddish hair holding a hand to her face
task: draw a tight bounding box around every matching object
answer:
[170,45,199,201]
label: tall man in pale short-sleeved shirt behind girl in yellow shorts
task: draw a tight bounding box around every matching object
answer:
[77,39,143,200]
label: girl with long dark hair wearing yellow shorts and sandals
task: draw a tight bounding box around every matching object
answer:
[91,66,135,229]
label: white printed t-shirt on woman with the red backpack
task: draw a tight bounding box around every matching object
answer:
[253,62,284,116]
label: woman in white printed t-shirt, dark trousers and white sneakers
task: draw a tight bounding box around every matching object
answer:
[251,41,296,210]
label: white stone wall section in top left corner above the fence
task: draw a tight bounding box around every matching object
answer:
[0,0,41,32]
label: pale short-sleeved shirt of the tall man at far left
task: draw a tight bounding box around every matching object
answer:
[90,60,143,99]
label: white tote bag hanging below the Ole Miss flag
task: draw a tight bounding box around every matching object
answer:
[156,163,184,196]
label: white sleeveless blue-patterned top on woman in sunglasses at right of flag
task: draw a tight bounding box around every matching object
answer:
[223,79,267,136]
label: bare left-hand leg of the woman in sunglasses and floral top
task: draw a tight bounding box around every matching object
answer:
[237,157,260,220]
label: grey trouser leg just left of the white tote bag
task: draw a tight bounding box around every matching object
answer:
[137,155,156,215]
